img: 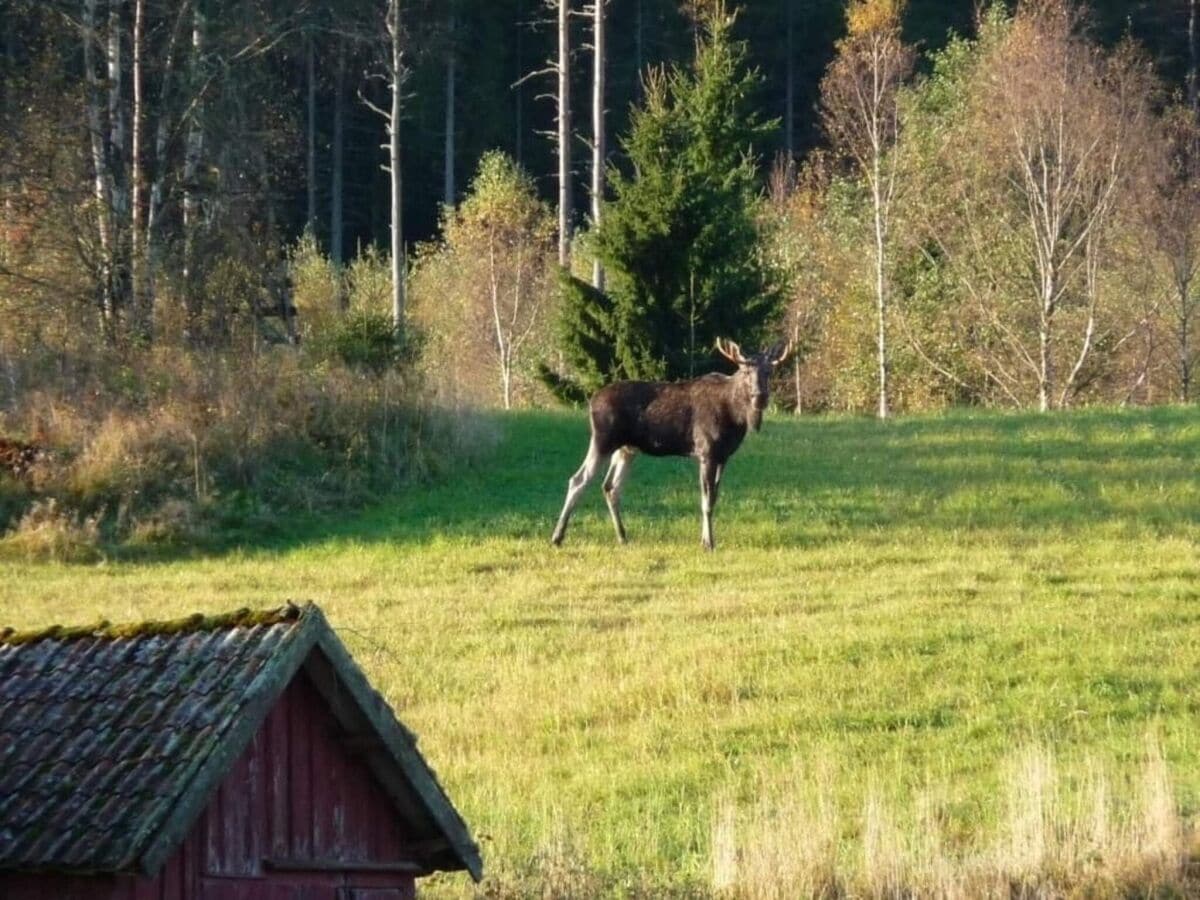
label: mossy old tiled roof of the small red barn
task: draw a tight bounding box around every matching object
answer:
[0,605,479,877]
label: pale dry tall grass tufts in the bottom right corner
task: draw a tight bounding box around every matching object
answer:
[710,733,1200,900]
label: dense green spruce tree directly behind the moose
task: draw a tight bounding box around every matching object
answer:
[546,4,781,397]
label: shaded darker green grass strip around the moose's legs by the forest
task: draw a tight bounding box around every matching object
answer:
[114,407,1200,560]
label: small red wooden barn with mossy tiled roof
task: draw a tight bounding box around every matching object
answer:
[0,605,481,900]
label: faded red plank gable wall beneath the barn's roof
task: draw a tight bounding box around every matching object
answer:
[0,672,415,900]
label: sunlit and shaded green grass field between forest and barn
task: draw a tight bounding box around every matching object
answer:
[0,408,1200,895]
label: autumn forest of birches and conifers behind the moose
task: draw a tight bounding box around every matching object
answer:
[0,0,1200,549]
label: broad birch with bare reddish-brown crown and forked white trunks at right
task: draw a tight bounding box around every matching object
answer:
[974,0,1148,412]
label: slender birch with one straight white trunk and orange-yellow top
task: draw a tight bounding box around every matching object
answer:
[821,0,913,419]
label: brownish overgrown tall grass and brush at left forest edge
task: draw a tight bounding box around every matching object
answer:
[0,347,497,558]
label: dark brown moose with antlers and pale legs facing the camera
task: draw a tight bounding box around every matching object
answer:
[551,338,792,550]
